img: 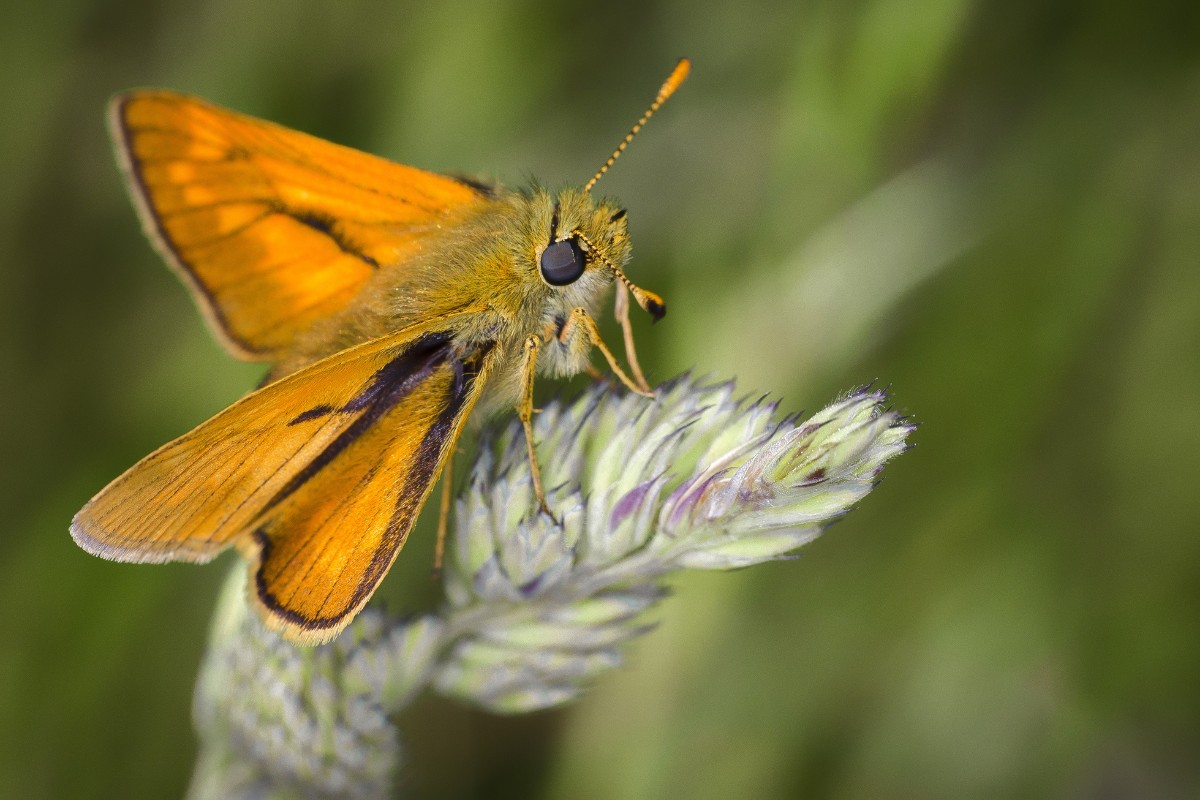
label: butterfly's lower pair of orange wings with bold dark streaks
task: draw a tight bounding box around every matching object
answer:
[71,325,492,643]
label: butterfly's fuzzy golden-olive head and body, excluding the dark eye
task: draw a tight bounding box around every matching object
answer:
[279,186,630,405]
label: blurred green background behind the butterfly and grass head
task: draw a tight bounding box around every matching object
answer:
[0,0,1200,798]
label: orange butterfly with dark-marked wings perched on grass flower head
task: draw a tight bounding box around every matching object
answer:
[71,59,690,644]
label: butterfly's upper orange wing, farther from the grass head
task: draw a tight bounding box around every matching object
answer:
[109,91,485,361]
